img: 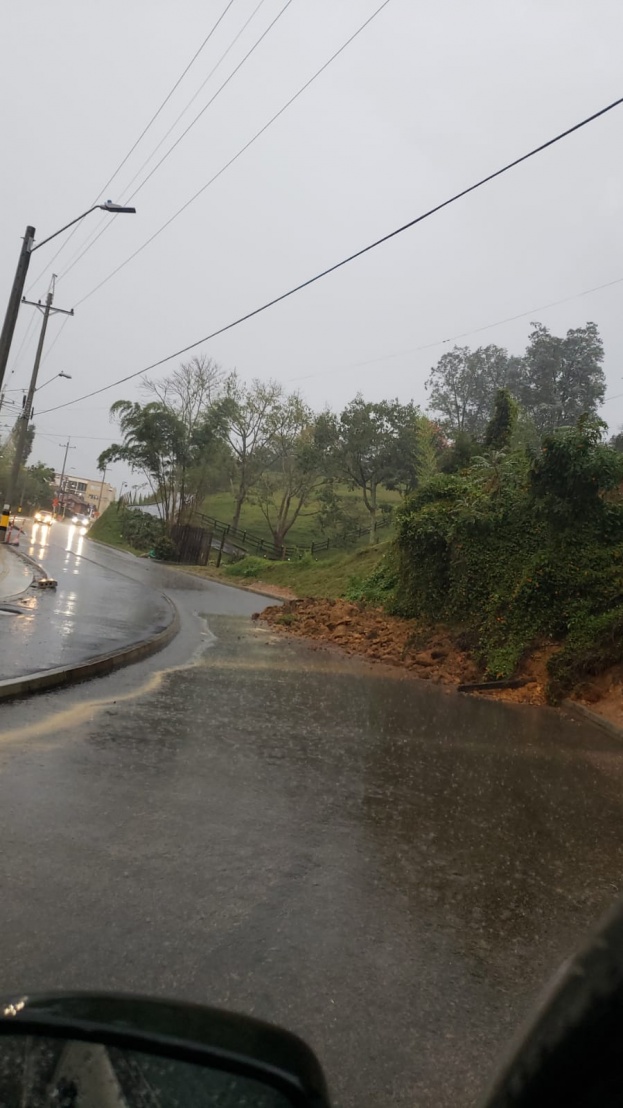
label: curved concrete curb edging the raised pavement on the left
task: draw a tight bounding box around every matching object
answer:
[0,596,180,700]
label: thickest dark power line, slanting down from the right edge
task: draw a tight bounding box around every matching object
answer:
[40,89,623,414]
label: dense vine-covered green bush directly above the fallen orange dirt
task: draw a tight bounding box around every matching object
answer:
[354,407,623,700]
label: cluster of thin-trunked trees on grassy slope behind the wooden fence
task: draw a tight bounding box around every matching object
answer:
[98,358,436,554]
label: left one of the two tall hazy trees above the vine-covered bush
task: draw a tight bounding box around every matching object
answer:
[426,346,512,438]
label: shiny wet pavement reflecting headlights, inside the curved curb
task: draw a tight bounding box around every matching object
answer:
[0,520,171,678]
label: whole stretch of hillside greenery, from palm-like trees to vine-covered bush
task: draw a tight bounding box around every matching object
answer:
[85,324,623,699]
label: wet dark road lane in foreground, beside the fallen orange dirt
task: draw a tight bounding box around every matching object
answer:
[0,554,623,1108]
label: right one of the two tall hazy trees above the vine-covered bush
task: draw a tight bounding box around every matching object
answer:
[509,324,605,433]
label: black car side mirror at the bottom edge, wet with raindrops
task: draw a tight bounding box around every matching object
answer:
[0,994,329,1108]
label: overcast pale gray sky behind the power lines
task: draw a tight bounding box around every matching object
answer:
[0,0,623,494]
